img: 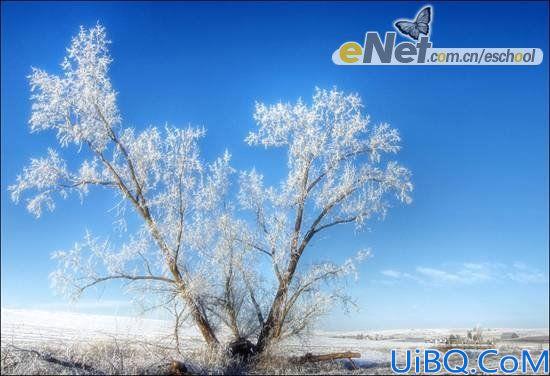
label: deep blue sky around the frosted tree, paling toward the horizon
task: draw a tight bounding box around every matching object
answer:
[1,2,549,329]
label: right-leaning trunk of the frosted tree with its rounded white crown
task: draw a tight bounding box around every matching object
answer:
[239,89,412,351]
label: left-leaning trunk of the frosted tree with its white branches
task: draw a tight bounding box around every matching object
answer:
[9,25,233,344]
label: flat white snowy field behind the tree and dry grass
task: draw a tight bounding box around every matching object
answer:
[1,309,548,369]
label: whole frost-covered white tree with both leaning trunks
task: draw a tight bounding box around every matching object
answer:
[9,25,412,352]
